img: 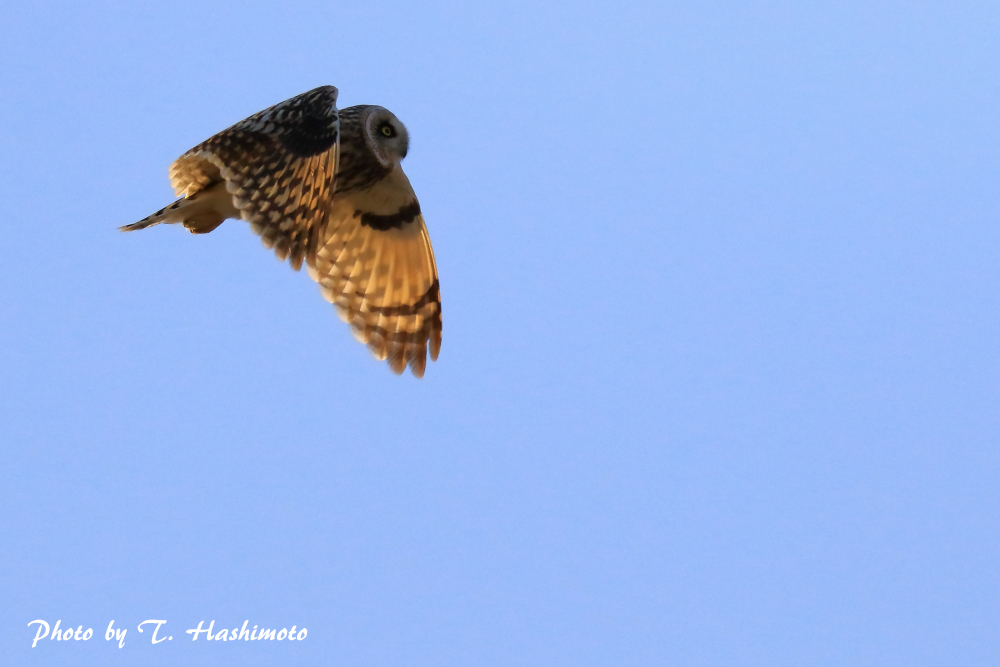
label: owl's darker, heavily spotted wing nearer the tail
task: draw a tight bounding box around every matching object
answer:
[170,86,340,270]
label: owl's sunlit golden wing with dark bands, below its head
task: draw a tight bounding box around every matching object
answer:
[308,165,441,377]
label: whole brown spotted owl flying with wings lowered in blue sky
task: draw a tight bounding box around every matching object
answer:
[121,86,441,377]
